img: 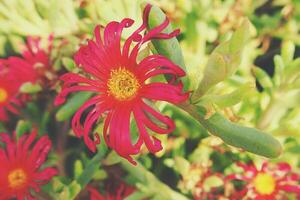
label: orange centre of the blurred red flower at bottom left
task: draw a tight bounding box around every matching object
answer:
[8,168,27,189]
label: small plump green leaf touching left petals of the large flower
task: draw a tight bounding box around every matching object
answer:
[56,92,92,121]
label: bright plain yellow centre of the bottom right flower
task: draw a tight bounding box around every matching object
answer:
[253,173,276,195]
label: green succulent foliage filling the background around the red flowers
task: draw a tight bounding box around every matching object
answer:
[0,0,300,200]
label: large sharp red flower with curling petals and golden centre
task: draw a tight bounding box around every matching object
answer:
[56,5,188,164]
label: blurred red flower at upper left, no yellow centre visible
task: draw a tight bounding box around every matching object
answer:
[7,35,55,87]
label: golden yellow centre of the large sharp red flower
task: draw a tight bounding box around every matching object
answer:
[107,68,140,101]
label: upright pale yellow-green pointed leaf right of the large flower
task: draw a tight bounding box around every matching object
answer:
[192,20,250,102]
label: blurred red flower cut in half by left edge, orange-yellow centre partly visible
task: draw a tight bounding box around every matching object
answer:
[0,60,22,121]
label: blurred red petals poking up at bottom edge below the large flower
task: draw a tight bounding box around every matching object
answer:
[88,183,135,200]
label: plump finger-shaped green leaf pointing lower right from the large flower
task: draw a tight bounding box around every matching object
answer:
[202,113,282,158]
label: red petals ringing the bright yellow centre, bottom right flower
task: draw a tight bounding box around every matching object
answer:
[226,162,300,200]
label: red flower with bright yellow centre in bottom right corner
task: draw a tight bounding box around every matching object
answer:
[226,162,300,200]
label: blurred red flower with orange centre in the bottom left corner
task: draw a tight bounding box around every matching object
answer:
[0,130,57,200]
